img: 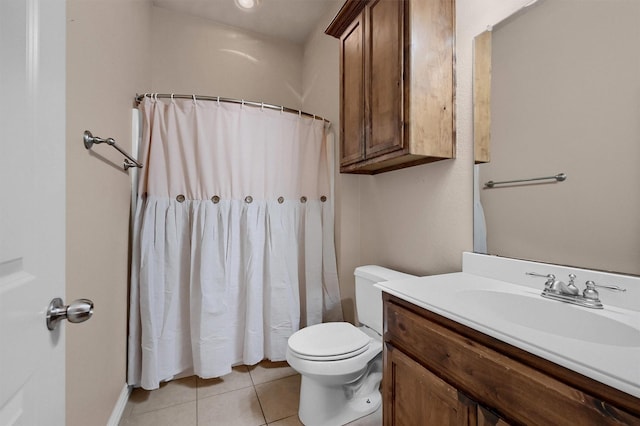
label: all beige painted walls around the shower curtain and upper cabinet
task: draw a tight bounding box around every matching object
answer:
[62,0,540,425]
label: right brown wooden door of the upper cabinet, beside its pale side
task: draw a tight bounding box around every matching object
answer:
[365,0,406,159]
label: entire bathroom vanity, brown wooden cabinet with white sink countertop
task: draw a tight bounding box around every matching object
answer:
[378,253,640,425]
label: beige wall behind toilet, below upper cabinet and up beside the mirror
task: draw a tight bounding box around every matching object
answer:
[339,0,526,286]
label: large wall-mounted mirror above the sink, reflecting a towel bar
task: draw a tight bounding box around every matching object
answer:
[474,0,640,275]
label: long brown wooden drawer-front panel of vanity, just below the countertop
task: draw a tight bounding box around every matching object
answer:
[384,302,640,425]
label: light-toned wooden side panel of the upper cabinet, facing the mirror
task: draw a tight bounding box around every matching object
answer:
[405,0,455,158]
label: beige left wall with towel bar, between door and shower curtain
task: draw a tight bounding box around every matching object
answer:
[66,0,151,426]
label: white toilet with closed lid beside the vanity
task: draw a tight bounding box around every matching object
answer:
[287,265,413,426]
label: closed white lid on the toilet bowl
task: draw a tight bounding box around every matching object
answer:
[289,322,371,361]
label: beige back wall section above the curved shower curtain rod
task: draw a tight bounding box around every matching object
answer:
[151,7,303,108]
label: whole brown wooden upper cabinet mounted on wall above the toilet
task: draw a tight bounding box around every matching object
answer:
[326,0,455,174]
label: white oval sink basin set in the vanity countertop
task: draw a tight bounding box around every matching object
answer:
[457,288,640,347]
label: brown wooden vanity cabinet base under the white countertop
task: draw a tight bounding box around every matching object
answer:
[382,293,640,426]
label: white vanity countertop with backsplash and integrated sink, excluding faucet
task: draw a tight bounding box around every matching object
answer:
[377,253,640,398]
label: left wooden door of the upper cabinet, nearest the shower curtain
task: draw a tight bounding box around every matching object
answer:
[340,14,365,166]
